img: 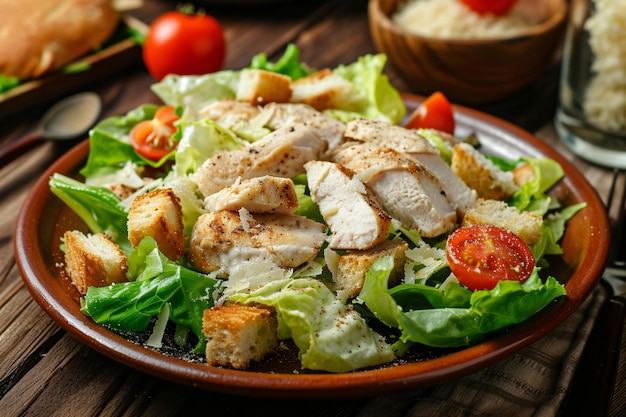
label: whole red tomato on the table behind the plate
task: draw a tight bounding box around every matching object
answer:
[143,11,226,81]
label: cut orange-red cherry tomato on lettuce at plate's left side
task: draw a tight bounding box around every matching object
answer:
[129,106,179,161]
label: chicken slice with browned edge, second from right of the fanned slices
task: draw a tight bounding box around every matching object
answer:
[334,142,457,238]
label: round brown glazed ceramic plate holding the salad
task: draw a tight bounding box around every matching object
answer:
[15,95,609,397]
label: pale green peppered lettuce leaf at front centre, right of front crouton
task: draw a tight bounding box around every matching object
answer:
[229,278,394,372]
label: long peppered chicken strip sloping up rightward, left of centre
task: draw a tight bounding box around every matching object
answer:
[194,123,327,196]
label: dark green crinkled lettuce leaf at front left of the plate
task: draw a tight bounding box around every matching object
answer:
[81,237,217,353]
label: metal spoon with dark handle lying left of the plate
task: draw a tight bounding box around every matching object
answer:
[0,92,102,168]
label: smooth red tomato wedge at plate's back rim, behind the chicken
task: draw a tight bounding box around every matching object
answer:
[404,91,455,135]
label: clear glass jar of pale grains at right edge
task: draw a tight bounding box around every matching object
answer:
[555,0,626,168]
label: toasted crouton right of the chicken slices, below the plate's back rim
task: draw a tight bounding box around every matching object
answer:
[450,143,519,200]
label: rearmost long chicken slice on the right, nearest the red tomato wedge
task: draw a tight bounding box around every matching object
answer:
[345,119,477,214]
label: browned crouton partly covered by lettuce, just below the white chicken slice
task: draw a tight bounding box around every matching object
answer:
[333,240,409,298]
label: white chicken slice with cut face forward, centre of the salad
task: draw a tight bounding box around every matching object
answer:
[304,161,391,250]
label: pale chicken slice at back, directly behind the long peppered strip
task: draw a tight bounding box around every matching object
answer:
[253,103,346,150]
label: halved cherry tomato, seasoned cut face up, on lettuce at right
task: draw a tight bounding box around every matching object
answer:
[446,224,535,291]
